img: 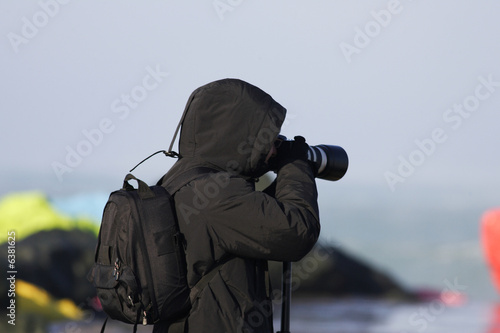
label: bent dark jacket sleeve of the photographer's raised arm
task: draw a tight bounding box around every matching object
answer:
[206,161,320,261]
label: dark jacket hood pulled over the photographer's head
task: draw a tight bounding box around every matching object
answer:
[172,79,286,177]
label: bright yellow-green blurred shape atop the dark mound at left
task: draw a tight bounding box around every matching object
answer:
[0,192,99,243]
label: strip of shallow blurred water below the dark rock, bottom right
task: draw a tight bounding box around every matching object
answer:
[274,298,500,333]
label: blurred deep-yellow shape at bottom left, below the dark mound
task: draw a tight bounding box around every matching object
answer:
[15,280,83,320]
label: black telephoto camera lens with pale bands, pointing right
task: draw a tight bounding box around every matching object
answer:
[277,135,349,181]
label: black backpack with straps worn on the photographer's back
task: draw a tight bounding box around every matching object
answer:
[88,167,218,332]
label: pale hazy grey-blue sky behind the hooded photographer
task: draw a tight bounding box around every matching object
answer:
[0,0,500,296]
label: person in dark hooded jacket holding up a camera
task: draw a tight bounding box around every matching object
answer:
[154,79,320,333]
